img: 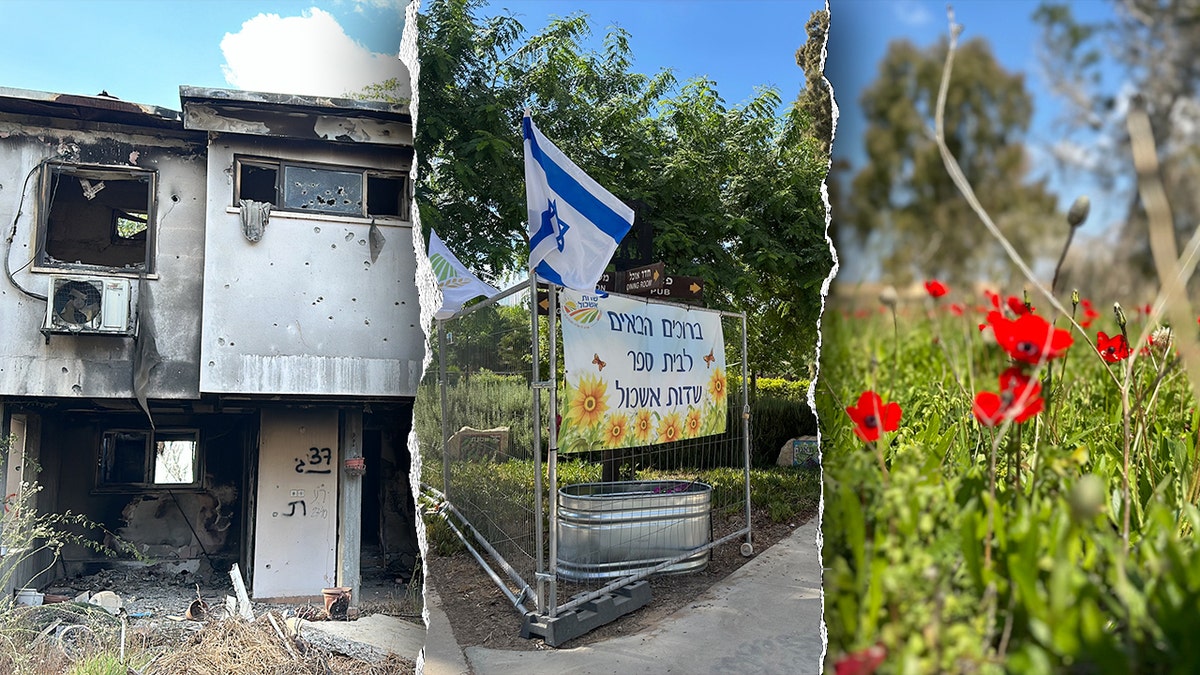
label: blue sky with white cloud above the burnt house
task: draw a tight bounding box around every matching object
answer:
[0,0,403,109]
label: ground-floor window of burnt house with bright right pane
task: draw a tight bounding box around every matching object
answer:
[96,429,200,488]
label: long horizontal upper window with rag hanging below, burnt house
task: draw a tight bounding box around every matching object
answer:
[234,157,409,220]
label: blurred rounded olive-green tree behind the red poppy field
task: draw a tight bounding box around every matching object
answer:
[842,38,1066,282]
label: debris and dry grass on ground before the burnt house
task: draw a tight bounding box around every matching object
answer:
[0,566,416,675]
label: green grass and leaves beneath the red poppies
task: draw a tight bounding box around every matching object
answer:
[818,302,1200,673]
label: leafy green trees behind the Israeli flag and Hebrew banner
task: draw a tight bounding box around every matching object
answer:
[416,0,832,374]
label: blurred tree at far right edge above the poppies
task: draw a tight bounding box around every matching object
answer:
[1034,0,1200,281]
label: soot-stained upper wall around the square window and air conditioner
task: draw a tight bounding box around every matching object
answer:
[0,113,205,399]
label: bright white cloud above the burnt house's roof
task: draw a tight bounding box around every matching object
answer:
[221,7,410,96]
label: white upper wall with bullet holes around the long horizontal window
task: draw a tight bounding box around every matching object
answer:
[200,135,425,396]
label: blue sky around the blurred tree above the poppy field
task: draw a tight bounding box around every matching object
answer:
[826,0,1127,277]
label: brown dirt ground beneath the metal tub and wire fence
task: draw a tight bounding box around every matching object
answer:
[428,509,812,651]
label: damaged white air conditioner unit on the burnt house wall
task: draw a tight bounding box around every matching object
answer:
[42,276,133,339]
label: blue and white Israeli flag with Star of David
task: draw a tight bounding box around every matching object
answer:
[522,110,634,292]
